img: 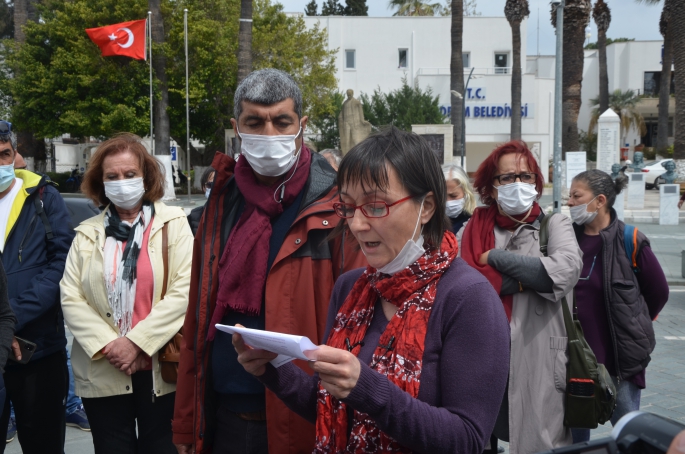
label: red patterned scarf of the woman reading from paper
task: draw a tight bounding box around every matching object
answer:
[314,232,458,454]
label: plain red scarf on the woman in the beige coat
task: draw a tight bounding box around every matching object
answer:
[461,202,540,321]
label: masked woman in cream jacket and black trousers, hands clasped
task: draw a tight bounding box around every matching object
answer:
[60,134,193,454]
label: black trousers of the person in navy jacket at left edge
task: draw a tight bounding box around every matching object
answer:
[0,351,69,454]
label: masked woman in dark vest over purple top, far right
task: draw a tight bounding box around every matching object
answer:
[568,170,668,442]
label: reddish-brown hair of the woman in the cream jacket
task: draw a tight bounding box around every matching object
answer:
[81,133,165,205]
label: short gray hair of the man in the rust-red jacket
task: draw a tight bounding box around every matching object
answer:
[233,68,302,121]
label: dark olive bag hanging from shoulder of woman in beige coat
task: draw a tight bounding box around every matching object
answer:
[540,216,616,429]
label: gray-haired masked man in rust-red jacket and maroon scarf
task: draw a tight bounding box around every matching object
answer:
[172,69,365,454]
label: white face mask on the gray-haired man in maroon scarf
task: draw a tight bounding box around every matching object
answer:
[236,126,302,177]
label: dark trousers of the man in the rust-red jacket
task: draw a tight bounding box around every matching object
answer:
[212,405,269,454]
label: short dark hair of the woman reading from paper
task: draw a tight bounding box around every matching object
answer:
[338,126,450,247]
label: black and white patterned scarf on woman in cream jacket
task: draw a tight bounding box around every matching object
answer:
[105,202,155,336]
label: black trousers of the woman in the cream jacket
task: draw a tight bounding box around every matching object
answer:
[81,370,177,454]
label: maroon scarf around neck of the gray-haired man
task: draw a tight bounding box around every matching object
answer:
[207,145,312,341]
